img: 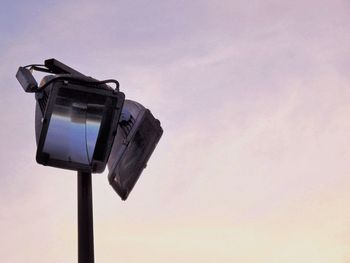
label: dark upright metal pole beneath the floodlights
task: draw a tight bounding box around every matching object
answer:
[78,172,94,263]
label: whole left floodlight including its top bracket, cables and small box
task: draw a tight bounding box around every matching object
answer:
[16,59,125,173]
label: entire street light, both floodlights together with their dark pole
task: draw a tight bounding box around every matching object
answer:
[16,59,163,263]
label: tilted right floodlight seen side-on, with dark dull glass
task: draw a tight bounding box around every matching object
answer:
[108,100,163,200]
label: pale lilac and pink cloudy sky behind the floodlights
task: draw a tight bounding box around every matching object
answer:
[0,0,350,263]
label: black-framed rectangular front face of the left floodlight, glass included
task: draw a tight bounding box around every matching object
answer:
[36,80,124,173]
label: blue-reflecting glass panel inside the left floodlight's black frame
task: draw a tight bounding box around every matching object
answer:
[43,88,105,165]
